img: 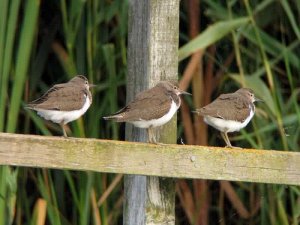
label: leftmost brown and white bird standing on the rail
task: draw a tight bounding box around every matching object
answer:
[25,75,96,137]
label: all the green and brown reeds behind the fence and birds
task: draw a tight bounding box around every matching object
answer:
[0,0,300,225]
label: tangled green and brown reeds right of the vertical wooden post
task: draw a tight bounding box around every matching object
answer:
[179,0,300,224]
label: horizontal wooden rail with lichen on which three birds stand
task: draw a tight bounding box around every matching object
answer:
[0,133,300,185]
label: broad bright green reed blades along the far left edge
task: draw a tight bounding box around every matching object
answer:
[0,0,39,225]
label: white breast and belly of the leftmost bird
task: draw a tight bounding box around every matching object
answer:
[35,96,91,124]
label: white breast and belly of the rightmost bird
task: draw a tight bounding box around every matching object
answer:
[204,108,254,132]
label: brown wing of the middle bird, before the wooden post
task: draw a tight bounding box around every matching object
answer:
[106,87,172,122]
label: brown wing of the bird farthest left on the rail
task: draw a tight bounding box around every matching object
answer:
[27,84,86,111]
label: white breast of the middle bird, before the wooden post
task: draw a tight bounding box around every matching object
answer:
[130,100,179,128]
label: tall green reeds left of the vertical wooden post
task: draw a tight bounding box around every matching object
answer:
[0,0,127,225]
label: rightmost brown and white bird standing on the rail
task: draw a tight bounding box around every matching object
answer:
[195,88,262,148]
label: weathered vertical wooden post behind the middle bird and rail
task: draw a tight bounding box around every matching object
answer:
[123,0,180,225]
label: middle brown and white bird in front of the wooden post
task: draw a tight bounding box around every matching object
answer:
[103,81,190,143]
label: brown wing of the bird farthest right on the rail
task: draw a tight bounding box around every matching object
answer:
[199,94,250,122]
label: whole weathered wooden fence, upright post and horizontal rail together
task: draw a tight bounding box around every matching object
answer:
[0,0,300,225]
